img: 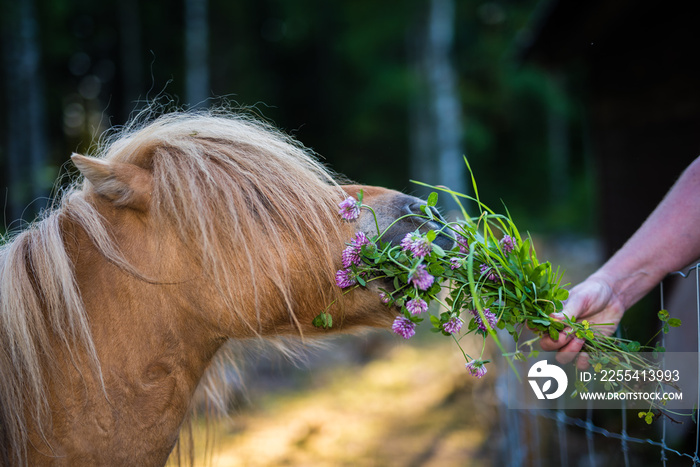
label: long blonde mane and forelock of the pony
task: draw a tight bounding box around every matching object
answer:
[0,112,343,464]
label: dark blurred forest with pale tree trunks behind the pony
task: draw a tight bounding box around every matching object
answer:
[0,0,594,234]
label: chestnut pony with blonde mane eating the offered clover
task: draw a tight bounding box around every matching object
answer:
[0,113,446,466]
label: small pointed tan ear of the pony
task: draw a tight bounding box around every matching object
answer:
[71,154,153,212]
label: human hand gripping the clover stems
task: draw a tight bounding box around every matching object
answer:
[540,277,625,369]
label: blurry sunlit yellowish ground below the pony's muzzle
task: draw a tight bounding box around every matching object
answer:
[182,335,496,467]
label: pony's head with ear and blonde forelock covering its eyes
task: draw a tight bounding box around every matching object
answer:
[67,114,448,337]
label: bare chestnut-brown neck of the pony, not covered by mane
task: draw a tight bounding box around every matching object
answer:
[29,200,224,465]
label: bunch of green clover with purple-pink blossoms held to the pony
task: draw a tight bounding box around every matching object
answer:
[313,165,680,421]
